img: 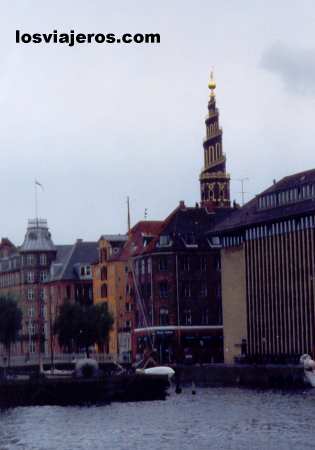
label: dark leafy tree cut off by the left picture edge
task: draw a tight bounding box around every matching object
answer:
[0,296,22,365]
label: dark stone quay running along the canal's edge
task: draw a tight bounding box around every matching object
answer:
[0,363,309,407]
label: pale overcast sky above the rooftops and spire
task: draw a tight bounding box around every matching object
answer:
[0,0,315,245]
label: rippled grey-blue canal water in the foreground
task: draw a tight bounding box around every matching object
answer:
[0,388,315,450]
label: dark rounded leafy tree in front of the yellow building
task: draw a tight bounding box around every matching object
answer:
[54,302,114,356]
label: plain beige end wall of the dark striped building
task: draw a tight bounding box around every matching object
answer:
[221,246,247,364]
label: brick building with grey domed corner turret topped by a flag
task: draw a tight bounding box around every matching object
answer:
[0,219,97,358]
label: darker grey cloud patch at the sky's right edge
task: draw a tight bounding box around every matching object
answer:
[261,42,315,96]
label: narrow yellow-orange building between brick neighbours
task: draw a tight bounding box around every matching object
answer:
[93,234,131,360]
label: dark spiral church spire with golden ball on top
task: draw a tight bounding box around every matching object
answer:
[199,72,230,208]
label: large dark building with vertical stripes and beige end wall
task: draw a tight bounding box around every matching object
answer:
[210,170,315,362]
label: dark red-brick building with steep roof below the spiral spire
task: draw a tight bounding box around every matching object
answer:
[132,202,231,362]
